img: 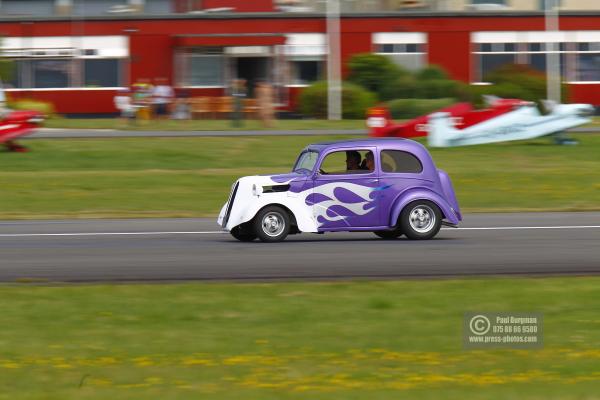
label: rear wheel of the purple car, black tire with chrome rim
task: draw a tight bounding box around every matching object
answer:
[400,200,442,240]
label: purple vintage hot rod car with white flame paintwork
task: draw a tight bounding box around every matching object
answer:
[218,138,462,242]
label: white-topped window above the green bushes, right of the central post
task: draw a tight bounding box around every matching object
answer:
[373,32,427,71]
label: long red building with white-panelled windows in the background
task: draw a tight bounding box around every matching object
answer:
[0,0,600,114]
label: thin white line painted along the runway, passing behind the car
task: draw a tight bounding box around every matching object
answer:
[0,225,600,238]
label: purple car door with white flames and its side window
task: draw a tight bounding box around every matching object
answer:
[307,147,380,231]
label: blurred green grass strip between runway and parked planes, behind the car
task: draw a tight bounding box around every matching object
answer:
[0,135,600,219]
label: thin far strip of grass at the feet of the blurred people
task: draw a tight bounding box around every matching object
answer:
[44,118,366,131]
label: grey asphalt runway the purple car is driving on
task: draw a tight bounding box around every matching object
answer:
[0,212,600,282]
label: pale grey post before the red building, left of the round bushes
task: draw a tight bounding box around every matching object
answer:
[326,0,342,121]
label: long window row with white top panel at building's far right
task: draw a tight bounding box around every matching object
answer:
[472,31,600,82]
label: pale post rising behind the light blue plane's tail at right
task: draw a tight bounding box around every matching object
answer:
[544,0,561,103]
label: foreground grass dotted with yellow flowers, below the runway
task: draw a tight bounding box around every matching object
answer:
[0,277,600,400]
